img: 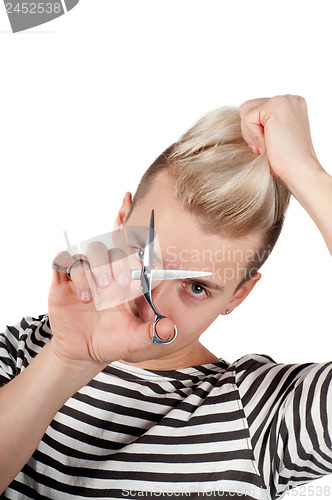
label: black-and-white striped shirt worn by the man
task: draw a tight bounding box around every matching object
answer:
[0,314,332,500]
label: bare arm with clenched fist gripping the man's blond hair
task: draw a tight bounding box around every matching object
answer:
[240,95,332,254]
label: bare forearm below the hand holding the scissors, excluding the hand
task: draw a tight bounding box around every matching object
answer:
[0,344,98,494]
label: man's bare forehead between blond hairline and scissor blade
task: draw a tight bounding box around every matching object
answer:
[128,173,262,279]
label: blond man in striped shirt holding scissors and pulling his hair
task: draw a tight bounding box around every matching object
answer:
[0,95,332,499]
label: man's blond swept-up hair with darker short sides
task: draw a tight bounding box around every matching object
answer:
[127,106,290,293]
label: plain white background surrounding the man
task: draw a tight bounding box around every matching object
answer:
[0,0,332,492]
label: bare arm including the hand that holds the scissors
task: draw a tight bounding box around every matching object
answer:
[0,237,174,496]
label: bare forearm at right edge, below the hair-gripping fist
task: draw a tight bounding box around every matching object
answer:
[286,165,332,255]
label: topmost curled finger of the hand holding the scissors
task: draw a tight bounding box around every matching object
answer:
[86,241,112,288]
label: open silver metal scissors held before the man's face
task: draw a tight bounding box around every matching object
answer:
[52,210,212,344]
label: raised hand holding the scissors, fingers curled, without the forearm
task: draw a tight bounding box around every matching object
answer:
[49,232,174,365]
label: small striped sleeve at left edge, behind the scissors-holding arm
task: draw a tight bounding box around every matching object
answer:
[0,314,52,387]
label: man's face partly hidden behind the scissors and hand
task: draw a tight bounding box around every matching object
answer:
[119,173,261,366]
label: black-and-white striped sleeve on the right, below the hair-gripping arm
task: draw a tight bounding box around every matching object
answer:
[238,355,332,498]
